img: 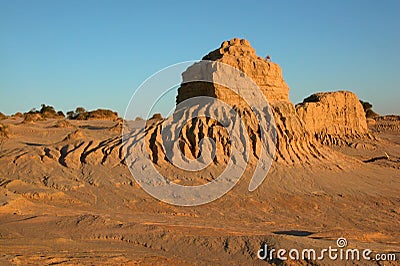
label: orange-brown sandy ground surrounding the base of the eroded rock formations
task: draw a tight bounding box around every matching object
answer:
[0,119,400,265]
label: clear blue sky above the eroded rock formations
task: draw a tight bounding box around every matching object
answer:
[0,0,400,115]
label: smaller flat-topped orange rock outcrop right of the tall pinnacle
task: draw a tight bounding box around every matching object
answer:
[296,91,368,144]
